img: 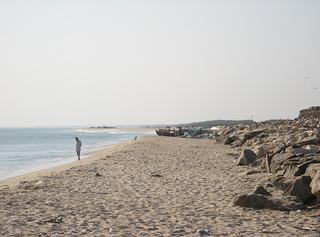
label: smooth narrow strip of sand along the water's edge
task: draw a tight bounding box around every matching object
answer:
[0,140,134,190]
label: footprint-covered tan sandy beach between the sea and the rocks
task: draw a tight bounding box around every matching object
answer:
[0,137,320,236]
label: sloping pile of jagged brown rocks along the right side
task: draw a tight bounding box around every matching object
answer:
[214,106,320,211]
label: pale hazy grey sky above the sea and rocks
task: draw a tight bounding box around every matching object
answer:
[0,0,320,127]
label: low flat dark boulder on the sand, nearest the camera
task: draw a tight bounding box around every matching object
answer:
[233,193,306,211]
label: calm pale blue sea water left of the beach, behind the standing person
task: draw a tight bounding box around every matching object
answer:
[0,128,153,180]
